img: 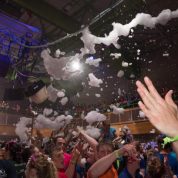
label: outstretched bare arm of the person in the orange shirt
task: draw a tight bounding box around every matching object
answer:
[88,145,135,178]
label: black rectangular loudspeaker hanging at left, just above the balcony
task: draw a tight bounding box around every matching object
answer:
[3,88,25,101]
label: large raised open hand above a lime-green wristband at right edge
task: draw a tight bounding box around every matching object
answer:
[136,77,178,137]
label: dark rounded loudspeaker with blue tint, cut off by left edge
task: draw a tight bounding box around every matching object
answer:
[0,54,10,77]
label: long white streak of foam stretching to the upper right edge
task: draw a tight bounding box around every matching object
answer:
[81,9,178,54]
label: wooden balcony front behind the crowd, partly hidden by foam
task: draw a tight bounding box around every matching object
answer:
[0,108,154,135]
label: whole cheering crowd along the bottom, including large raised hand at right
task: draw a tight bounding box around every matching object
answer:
[0,77,178,178]
